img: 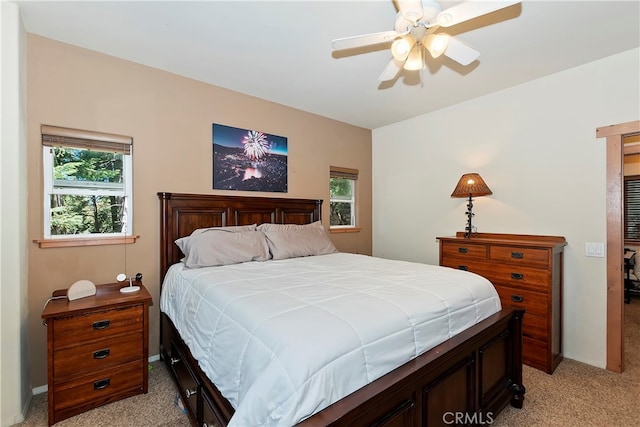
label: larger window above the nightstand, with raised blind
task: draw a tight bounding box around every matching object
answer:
[42,126,133,239]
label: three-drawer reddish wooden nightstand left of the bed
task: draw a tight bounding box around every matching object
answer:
[42,282,151,425]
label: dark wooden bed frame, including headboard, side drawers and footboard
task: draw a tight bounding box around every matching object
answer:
[158,193,525,427]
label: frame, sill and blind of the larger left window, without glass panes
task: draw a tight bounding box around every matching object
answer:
[36,125,137,247]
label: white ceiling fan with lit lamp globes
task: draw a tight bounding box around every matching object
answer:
[332,0,520,81]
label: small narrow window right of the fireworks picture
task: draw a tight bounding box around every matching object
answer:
[329,166,358,228]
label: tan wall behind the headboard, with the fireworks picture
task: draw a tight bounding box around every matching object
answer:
[27,34,372,386]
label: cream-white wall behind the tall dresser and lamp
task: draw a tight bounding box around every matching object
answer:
[373,49,640,367]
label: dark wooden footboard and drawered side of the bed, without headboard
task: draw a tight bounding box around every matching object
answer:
[161,309,525,427]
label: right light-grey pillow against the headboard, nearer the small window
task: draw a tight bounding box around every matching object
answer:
[264,227,338,259]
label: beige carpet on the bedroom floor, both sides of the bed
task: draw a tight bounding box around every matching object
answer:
[18,298,640,427]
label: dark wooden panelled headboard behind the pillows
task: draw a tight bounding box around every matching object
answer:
[158,193,322,280]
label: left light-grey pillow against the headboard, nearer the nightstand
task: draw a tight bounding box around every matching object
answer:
[176,229,271,268]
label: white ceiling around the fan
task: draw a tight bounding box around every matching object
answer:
[17,0,640,129]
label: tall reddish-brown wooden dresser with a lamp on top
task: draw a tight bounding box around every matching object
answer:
[437,232,567,374]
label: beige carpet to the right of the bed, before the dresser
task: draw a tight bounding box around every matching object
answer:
[492,298,640,427]
